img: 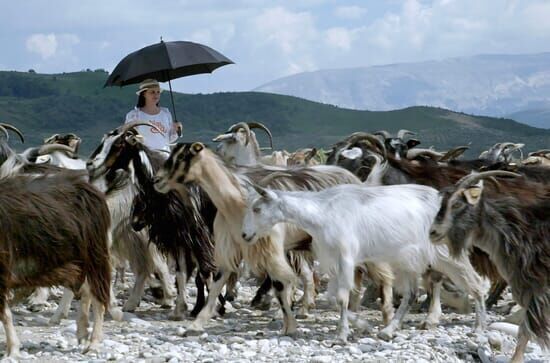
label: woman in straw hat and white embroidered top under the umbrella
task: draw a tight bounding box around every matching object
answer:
[126,78,182,152]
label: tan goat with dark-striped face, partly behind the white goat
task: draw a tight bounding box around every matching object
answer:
[155,143,391,334]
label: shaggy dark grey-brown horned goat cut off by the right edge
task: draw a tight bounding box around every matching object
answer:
[430,171,550,362]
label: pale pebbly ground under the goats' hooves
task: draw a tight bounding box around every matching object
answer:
[0,280,550,363]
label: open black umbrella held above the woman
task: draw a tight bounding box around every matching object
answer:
[103,39,233,120]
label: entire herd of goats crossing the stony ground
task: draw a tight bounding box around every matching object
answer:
[0,122,550,362]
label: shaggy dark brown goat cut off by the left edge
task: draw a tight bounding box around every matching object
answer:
[0,171,111,358]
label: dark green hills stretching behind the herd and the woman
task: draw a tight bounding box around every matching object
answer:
[0,70,550,156]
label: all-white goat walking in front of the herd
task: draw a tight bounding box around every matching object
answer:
[242,185,485,341]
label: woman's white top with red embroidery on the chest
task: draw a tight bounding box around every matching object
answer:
[125,107,178,151]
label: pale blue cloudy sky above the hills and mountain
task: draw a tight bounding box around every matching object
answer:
[0,0,550,93]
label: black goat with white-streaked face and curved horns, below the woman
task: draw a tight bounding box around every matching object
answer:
[88,124,224,319]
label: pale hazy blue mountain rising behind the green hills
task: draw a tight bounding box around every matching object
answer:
[255,53,550,128]
